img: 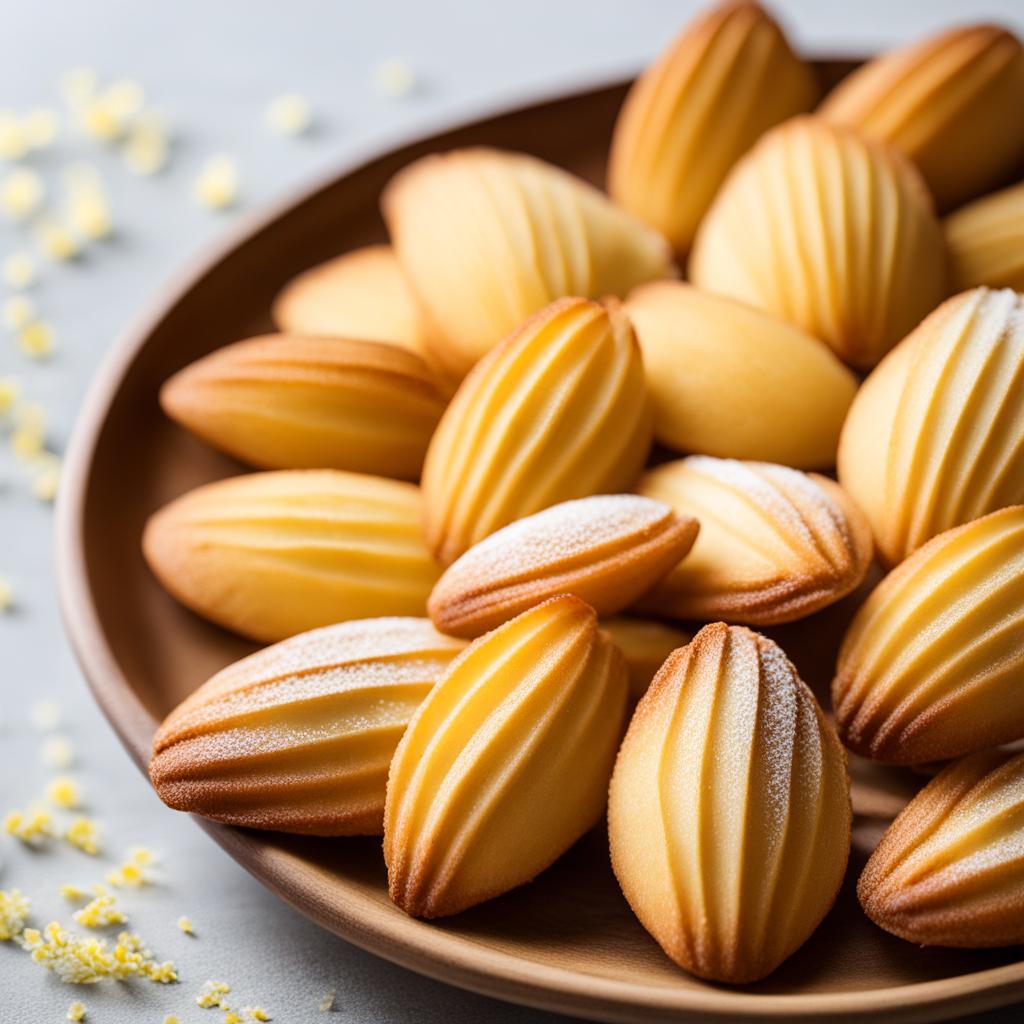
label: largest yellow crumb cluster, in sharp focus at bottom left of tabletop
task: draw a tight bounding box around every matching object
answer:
[19,921,177,985]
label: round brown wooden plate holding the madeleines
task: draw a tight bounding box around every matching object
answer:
[59,74,1024,1021]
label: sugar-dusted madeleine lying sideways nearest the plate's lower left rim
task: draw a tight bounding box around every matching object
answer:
[150,618,465,836]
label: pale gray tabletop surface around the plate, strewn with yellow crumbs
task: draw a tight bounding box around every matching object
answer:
[0,0,1024,1024]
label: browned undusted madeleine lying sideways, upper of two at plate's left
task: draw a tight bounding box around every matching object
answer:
[160,335,445,480]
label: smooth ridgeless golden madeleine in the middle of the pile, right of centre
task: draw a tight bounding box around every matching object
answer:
[626,281,857,469]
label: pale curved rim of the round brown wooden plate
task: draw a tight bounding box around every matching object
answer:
[56,76,1024,1024]
